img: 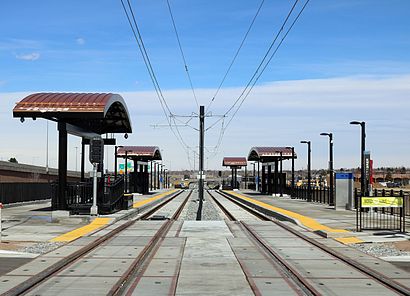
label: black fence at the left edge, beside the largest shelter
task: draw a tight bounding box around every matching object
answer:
[0,183,51,204]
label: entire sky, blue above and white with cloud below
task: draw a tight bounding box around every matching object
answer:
[0,0,410,169]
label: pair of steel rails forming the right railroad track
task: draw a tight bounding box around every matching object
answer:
[208,191,410,295]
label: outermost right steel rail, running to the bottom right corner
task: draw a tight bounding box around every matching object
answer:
[218,191,410,295]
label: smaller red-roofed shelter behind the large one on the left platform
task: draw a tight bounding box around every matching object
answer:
[115,146,164,194]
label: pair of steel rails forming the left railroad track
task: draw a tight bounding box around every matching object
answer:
[1,191,192,296]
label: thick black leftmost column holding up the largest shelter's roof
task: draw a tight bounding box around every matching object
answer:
[56,122,67,210]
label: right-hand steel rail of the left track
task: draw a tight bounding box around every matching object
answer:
[107,190,192,296]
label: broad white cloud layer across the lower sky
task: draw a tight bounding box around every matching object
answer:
[0,75,410,169]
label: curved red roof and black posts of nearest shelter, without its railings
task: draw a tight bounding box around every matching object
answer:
[13,93,132,210]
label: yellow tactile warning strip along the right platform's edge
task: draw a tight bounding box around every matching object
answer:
[228,191,362,244]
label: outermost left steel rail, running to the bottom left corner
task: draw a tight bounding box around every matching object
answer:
[1,191,183,296]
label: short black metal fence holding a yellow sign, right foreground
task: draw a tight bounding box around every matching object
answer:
[354,189,408,232]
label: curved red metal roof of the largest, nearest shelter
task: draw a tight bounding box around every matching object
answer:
[13,93,132,134]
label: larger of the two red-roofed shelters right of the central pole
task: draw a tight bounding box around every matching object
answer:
[248,147,297,195]
